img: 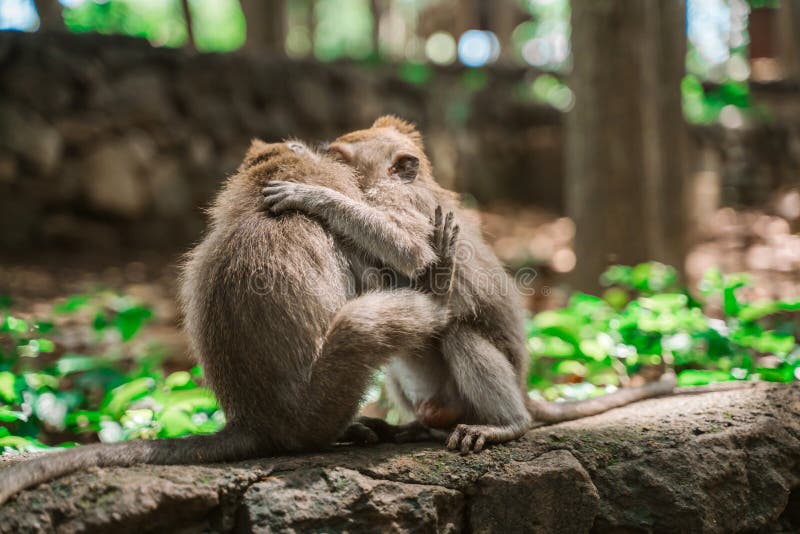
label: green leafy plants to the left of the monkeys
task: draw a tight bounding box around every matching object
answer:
[0,293,225,451]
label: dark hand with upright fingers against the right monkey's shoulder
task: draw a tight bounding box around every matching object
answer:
[415,206,459,297]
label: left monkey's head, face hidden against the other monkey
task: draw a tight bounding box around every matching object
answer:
[237,139,360,196]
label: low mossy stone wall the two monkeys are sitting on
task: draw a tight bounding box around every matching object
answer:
[0,384,800,533]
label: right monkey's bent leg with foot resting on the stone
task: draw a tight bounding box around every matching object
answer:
[442,326,531,453]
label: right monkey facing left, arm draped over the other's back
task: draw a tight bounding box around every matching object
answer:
[262,116,675,453]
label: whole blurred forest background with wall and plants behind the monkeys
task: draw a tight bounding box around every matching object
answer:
[0,0,800,445]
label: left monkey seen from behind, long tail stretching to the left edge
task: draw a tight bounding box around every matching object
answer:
[0,140,454,503]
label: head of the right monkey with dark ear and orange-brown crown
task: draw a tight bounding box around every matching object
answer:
[328,115,434,188]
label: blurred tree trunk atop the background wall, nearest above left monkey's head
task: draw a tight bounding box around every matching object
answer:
[242,0,286,55]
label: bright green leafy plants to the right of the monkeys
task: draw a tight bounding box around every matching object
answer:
[527,263,800,399]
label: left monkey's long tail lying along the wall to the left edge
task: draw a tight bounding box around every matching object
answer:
[0,428,262,505]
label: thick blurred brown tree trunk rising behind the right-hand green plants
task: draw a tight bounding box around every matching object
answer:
[566,0,686,291]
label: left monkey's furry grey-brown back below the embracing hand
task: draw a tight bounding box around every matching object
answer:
[181,158,358,450]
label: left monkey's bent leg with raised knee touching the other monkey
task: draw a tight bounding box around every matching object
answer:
[306,289,448,443]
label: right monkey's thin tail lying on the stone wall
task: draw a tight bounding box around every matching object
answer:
[528,373,676,424]
